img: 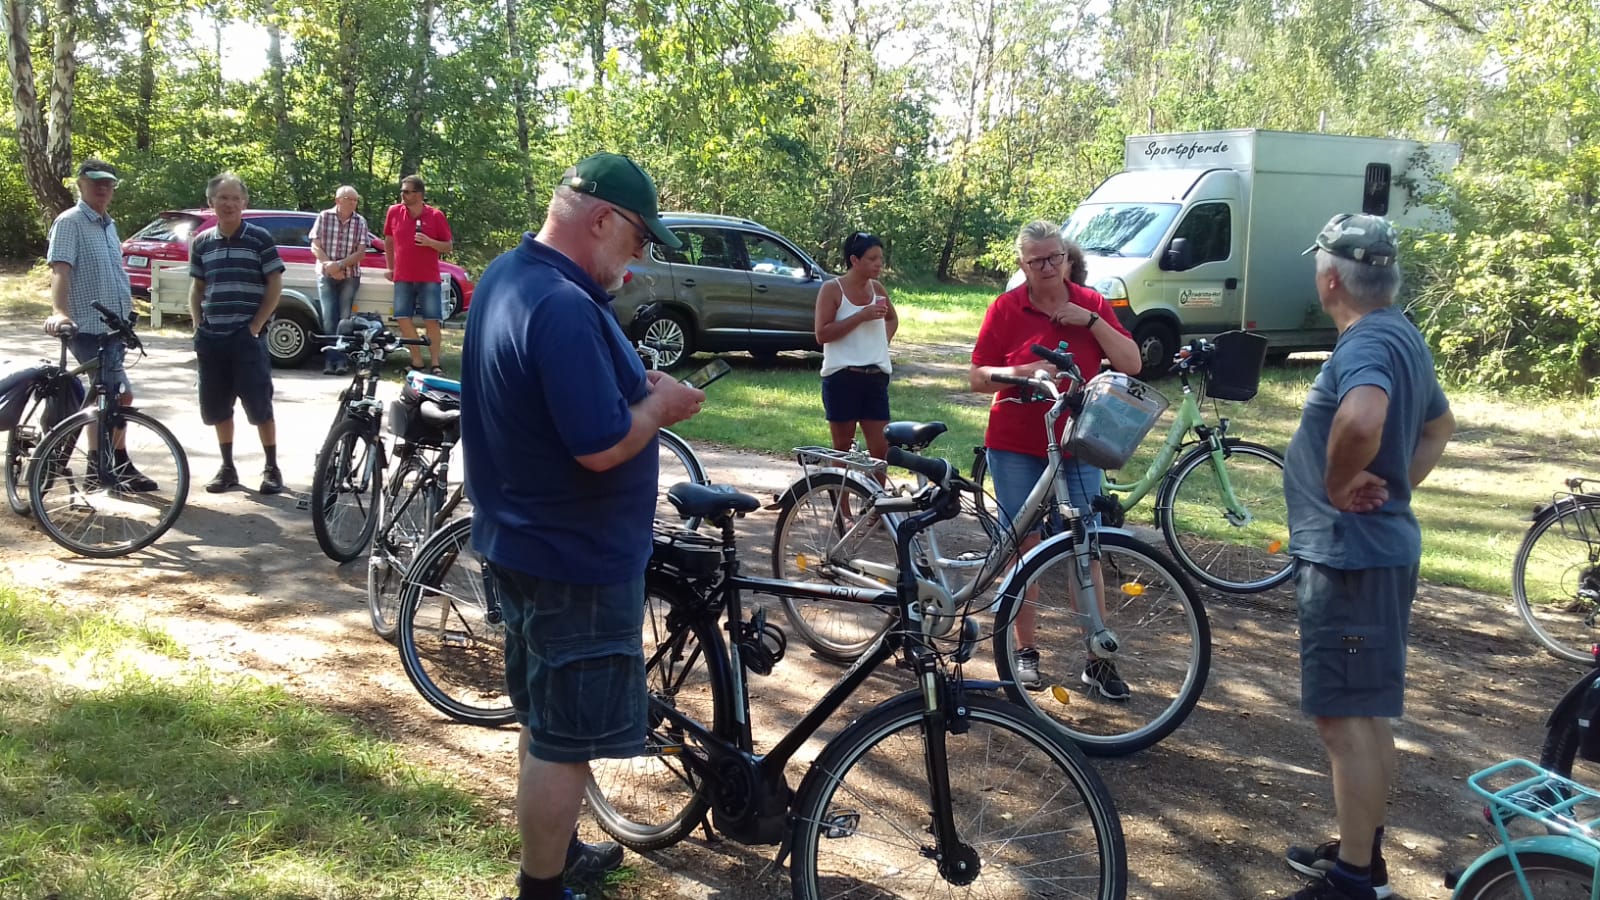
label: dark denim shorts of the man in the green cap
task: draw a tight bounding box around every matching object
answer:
[485,562,646,762]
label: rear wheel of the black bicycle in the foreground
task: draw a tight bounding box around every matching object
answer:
[584,578,731,854]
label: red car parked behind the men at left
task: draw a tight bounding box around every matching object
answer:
[122,210,472,319]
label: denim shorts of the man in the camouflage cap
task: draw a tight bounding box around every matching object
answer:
[1294,559,1418,719]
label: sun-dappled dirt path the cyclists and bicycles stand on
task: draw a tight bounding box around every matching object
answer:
[0,310,1578,900]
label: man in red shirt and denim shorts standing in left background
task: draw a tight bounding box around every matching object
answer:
[384,175,454,375]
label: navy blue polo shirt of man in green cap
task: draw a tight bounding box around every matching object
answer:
[461,234,659,585]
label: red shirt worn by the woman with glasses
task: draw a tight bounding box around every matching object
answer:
[973,282,1131,456]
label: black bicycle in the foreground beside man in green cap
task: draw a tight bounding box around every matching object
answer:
[586,450,1128,900]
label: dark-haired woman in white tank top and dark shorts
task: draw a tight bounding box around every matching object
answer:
[816,231,899,460]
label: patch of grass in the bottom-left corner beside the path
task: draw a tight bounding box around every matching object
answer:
[0,585,517,900]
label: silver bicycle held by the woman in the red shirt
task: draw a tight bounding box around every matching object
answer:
[773,339,1211,756]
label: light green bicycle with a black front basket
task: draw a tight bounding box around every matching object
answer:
[973,325,1294,594]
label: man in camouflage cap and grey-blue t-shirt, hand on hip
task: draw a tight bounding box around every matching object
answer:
[1283,215,1456,900]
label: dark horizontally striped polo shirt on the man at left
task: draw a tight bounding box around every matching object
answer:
[189,221,283,335]
